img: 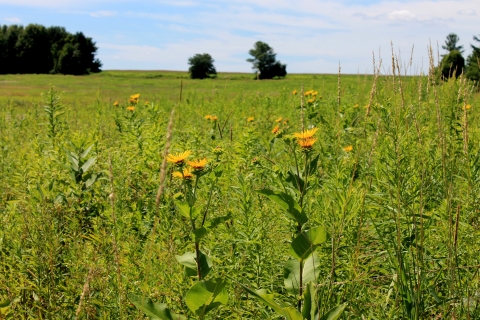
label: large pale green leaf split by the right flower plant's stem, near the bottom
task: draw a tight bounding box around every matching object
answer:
[283,252,320,294]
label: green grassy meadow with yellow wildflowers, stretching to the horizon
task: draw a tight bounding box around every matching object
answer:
[0,63,480,320]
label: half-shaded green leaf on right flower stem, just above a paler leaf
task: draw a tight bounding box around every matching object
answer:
[290,226,327,260]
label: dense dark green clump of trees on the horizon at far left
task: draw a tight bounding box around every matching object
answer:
[0,24,102,75]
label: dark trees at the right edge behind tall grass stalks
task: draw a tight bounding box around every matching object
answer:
[438,33,480,81]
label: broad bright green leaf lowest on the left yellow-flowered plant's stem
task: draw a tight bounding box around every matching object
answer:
[185,279,228,318]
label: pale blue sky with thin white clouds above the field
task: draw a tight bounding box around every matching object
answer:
[0,0,480,74]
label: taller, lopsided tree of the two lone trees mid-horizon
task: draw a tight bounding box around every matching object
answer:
[247,41,287,79]
